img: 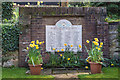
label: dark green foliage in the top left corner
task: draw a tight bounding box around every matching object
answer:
[2,2,13,20]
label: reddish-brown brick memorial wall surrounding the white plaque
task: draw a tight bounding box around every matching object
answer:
[19,7,109,67]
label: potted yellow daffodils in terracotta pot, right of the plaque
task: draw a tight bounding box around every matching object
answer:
[85,38,104,74]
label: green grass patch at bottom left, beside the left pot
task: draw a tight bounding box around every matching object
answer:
[2,68,54,80]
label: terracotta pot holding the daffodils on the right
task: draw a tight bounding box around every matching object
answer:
[89,62,102,74]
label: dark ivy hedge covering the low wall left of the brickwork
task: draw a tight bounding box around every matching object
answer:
[2,24,20,54]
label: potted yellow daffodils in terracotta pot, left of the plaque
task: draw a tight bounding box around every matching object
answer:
[27,40,44,75]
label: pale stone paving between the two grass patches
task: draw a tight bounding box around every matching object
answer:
[41,69,90,80]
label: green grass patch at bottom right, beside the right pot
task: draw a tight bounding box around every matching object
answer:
[78,67,120,80]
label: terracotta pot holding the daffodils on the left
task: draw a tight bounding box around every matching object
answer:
[29,64,42,75]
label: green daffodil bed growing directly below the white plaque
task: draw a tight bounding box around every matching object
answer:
[44,45,88,68]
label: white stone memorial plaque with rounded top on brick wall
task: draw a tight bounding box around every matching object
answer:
[46,19,82,52]
